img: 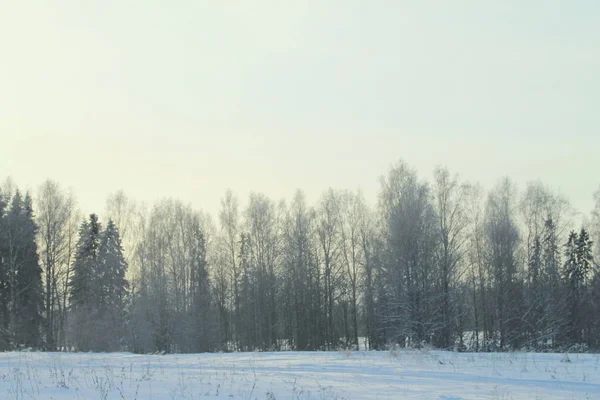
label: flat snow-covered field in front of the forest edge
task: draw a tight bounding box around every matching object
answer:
[0,351,600,400]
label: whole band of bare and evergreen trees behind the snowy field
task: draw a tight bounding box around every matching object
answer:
[0,161,600,353]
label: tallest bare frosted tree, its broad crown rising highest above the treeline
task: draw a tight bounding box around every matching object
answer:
[380,162,438,346]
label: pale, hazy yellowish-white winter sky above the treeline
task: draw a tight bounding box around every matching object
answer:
[0,0,600,219]
